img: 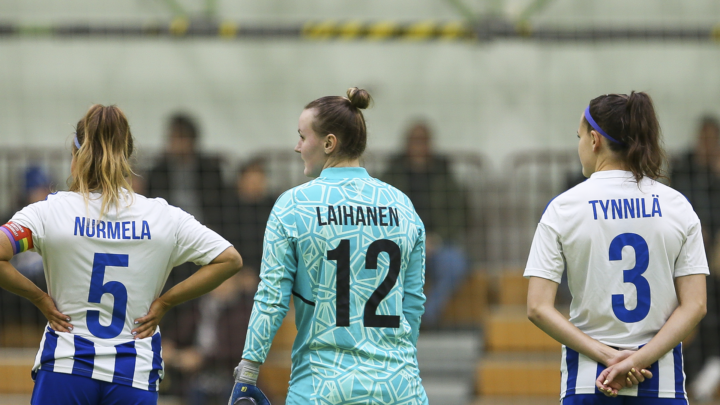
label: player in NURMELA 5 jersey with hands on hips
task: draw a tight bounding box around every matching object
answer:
[0,105,242,405]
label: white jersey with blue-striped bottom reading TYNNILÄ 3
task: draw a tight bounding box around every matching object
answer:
[525,170,709,398]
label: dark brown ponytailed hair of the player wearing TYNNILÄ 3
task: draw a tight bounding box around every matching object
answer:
[583,91,667,182]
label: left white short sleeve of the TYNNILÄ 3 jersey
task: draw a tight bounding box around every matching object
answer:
[524,222,565,283]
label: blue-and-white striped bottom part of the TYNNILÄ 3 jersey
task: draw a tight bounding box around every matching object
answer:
[560,343,687,400]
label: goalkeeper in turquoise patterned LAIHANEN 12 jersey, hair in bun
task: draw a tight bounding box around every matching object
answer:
[230,88,427,405]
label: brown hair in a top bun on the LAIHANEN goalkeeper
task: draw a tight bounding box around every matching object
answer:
[305,87,372,159]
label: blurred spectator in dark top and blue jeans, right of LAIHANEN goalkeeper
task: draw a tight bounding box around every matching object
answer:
[382,122,470,327]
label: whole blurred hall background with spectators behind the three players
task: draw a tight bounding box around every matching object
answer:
[0,0,720,405]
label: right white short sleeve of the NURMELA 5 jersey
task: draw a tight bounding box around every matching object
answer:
[170,207,232,267]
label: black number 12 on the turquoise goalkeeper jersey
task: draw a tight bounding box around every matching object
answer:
[327,239,400,328]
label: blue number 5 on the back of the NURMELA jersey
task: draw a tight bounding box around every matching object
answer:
[87,253,128,339]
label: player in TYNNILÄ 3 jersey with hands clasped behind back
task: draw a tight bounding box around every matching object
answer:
[525,92,709,405]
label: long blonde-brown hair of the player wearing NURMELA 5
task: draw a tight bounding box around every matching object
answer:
[70,104,135,218]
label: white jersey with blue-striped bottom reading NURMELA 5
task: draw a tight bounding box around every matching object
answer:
[11,192,231,391]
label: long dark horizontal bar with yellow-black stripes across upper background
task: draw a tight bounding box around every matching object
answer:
[0,17,720,43]
